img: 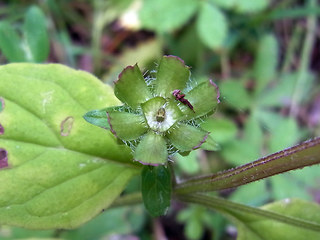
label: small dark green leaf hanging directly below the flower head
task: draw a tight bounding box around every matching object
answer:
[141,166,171,217]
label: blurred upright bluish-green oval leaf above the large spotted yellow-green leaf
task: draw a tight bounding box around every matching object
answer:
[23,6,50,62]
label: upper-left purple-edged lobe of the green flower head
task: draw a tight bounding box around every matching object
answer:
[114,64,152,108]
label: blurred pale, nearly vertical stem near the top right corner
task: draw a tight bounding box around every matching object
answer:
[290,0,317,116]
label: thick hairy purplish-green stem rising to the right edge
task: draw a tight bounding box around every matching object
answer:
[175,137,320,194]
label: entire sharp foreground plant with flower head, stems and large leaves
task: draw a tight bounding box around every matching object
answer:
[0,56,320,239]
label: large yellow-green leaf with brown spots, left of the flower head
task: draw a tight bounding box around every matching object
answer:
[0,64,139,229]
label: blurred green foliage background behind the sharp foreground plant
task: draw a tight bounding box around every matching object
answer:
[0,0,320,240]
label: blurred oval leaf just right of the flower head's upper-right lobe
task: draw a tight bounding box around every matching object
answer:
[219,80,253,110]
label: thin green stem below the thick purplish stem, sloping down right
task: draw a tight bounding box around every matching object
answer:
[177,194,320,231]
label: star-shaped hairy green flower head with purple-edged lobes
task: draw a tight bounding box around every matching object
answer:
[84,56,219,166]
